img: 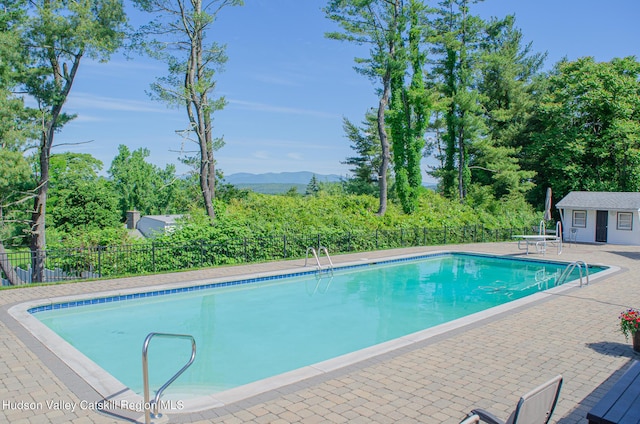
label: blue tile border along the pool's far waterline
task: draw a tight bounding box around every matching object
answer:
[27,252,607,314]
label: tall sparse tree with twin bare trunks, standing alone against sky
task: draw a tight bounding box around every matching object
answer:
[135,0,243,222]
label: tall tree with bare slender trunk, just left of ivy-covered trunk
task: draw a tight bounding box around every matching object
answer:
[325,0,404,215]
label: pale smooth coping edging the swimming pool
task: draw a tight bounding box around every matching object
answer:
[8,250,620,414]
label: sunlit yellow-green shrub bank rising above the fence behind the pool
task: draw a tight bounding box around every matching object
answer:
[218,189,537,235]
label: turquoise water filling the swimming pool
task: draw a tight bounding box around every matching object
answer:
[30,254,601,396]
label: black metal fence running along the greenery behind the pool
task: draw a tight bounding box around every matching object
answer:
[0,225,532,285]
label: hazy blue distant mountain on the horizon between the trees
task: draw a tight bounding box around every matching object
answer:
[224,171,342,194]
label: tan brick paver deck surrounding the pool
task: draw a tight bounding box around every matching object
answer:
[0,243,640,424]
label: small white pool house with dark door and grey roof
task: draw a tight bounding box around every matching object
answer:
[556,191,640,245]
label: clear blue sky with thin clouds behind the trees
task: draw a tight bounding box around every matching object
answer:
[54,0,640,181]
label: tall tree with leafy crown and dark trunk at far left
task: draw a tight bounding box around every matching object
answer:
[16,0,126,281]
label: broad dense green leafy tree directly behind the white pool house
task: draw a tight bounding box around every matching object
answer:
[523,57,640,202]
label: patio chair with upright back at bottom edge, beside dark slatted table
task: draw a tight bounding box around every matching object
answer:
[462,375,562,424]
